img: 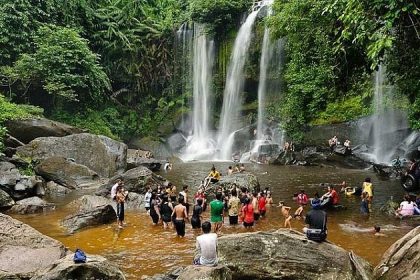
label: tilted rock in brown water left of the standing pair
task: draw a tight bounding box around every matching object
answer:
[61,204,117,233]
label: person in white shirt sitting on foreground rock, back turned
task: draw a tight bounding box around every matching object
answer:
[194,222,217,266]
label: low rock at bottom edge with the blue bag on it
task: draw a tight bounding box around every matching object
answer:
[31,254,125,280]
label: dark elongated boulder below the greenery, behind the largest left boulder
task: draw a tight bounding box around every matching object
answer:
[6,118,83,143]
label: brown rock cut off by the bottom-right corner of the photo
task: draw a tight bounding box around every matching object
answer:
[374,226,420,280]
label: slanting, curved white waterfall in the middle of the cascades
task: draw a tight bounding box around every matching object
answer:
[217,10,259,160]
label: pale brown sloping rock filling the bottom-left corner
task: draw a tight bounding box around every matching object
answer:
[0,214,66,279]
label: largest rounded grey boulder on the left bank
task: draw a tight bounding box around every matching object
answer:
[17,133,127,177]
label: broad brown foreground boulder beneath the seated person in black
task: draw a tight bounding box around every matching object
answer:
[218,230,371,280]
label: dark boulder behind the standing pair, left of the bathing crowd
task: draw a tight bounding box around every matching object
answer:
[95,166,167,196]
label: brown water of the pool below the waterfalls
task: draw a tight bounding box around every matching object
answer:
[10,162,420,279]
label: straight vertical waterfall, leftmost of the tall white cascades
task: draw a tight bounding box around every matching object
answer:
[182,24,216,160]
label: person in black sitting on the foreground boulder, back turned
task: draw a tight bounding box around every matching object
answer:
[303,198,327,242]
